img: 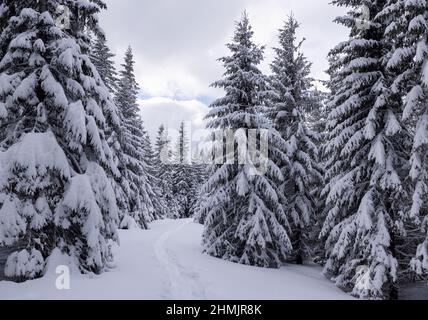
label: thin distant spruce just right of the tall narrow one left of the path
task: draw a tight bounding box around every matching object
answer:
[155,125,179,219]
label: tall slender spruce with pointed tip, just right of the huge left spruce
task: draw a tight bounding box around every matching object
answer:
[116,47,154,229]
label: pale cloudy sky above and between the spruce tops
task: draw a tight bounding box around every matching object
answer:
[101,0,347,140]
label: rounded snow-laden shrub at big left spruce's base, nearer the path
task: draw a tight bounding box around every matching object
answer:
[55,163,118,272]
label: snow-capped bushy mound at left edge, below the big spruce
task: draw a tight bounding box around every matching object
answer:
[0,132,71,256]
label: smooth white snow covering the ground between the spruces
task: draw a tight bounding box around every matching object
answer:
[0,219,351,300]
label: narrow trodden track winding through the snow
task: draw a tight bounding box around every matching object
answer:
[153,219,205,300]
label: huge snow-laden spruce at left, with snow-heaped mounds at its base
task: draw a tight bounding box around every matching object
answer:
[0,0,118,281]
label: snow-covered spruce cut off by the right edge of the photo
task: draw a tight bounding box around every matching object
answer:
[381,0,428,276]
